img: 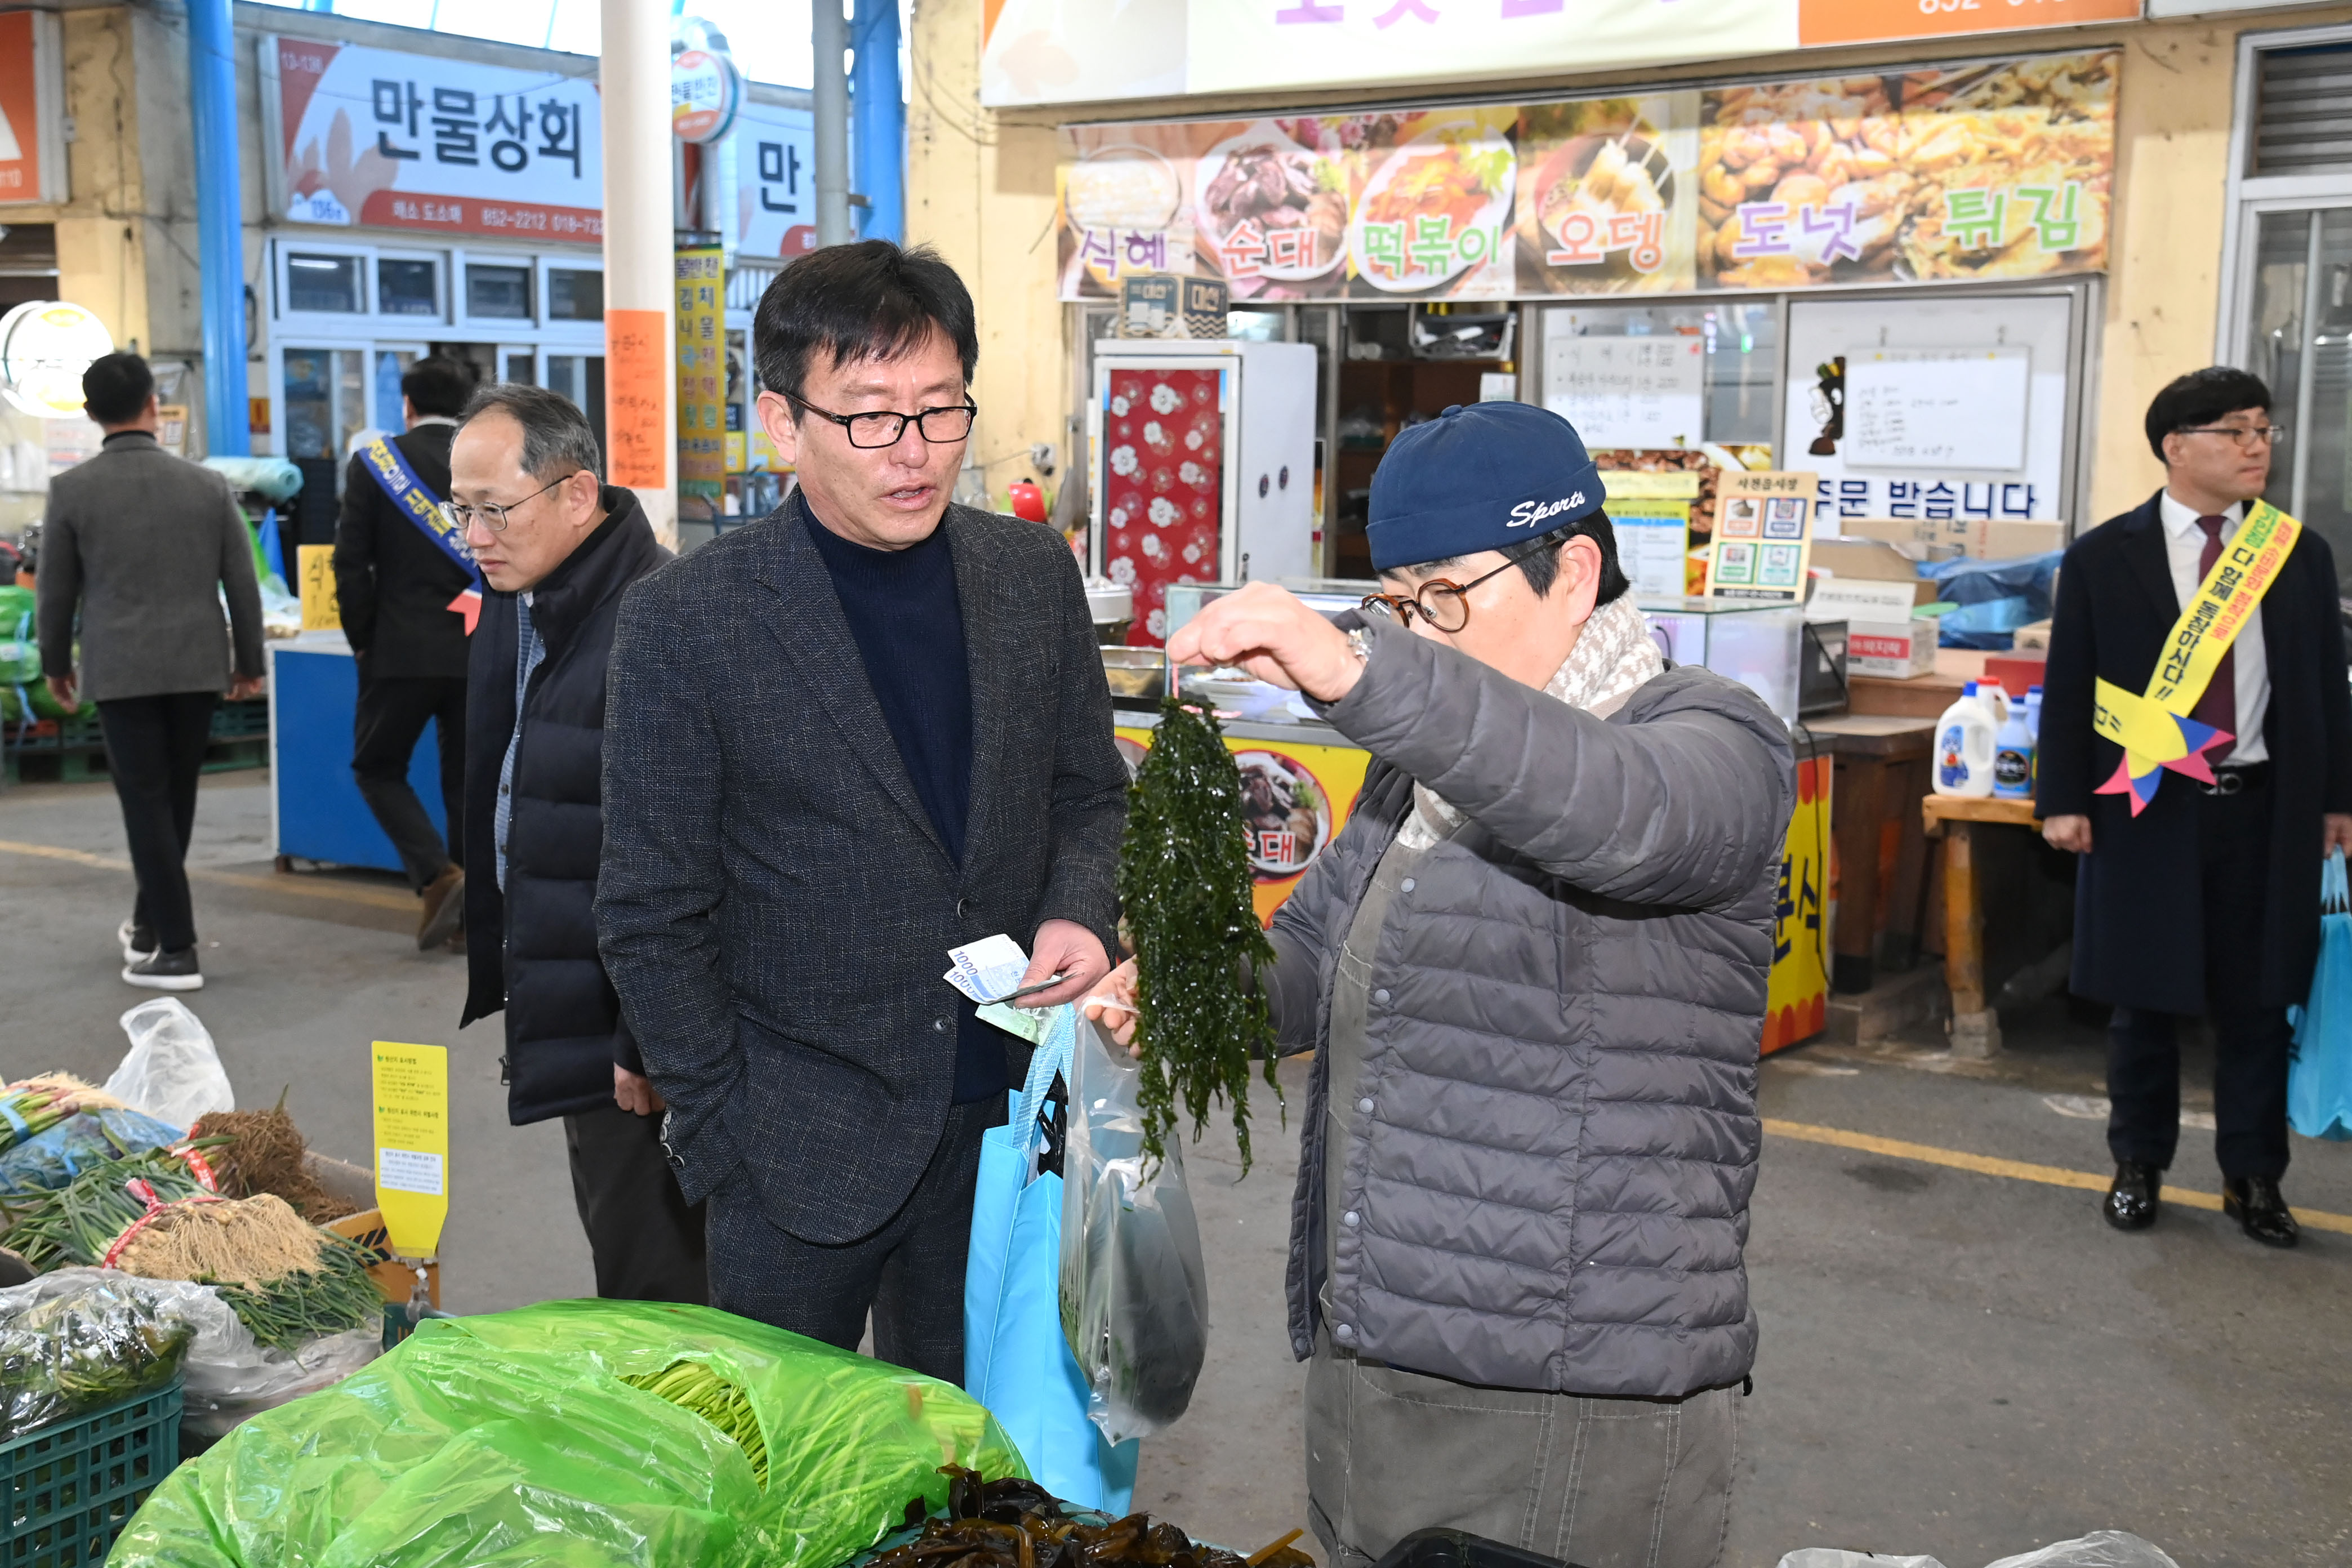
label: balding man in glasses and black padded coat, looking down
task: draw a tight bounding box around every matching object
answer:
[449,386,708,1302]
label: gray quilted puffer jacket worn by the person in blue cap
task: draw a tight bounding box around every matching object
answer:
[1270,618,1794,1398]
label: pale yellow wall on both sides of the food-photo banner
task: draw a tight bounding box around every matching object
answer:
[908,0,2352,527]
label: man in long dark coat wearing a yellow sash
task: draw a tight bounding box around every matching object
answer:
[2037,367,2352,1246]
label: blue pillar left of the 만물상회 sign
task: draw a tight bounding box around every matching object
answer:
[188,0,254,458]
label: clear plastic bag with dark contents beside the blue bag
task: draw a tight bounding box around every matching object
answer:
[1061,1020,1209,1444]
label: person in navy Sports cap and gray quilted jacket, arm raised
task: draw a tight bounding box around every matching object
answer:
[1092,402,1794,1568]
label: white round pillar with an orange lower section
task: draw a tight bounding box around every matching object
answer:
[598,0,678,550]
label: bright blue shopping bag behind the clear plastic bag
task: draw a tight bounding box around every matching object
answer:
[964,1006,1138,1518]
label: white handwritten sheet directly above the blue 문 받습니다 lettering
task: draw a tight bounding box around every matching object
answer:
[1846,348,2032,473]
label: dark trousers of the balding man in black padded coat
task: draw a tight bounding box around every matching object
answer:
[564,1105,710,1307]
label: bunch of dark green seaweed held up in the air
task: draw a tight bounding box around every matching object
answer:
[1120,696,1282,1175]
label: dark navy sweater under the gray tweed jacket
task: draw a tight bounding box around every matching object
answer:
[800,498,1006,1105]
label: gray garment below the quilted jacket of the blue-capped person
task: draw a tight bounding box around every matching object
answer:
[1306,1328,1740,1568]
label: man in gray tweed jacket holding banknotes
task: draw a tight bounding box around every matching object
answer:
[595,240,1126,1382]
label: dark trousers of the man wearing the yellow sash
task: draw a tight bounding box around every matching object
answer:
[2108,778,2286,1180]
